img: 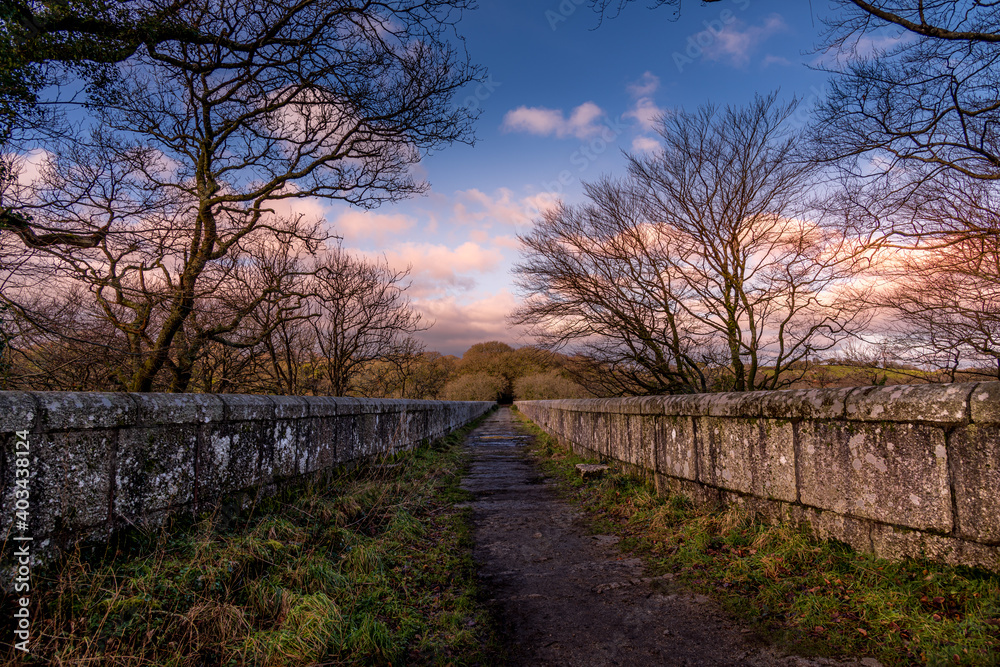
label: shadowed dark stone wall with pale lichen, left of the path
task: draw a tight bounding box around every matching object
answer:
[0,392,493,553]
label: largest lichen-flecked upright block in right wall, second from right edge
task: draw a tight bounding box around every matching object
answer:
[798,421,952,533]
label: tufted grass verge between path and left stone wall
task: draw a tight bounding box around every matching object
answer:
[0,418,501,667]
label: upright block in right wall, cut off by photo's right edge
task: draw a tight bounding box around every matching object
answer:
[948,422,1000,544]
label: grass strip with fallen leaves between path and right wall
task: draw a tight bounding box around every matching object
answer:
[516,414,1000,665]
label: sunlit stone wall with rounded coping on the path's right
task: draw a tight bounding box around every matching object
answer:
[517,382,1000,569]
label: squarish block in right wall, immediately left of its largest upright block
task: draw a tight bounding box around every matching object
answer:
[696,417,796,502]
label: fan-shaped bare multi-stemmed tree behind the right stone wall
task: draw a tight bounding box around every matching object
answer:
[512,95,862,393]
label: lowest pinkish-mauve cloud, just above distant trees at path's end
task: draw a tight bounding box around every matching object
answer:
[414,290,525,356]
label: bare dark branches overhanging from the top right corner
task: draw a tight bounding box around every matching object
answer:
[813,0,1000,245]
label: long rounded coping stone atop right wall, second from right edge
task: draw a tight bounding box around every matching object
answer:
[844,383,976,424]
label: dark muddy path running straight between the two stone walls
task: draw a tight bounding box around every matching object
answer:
[463,408,877,667]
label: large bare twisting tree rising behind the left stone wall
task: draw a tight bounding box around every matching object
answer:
[2,0,478,391]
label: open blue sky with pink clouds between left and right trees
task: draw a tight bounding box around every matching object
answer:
[316,0,844,356]
